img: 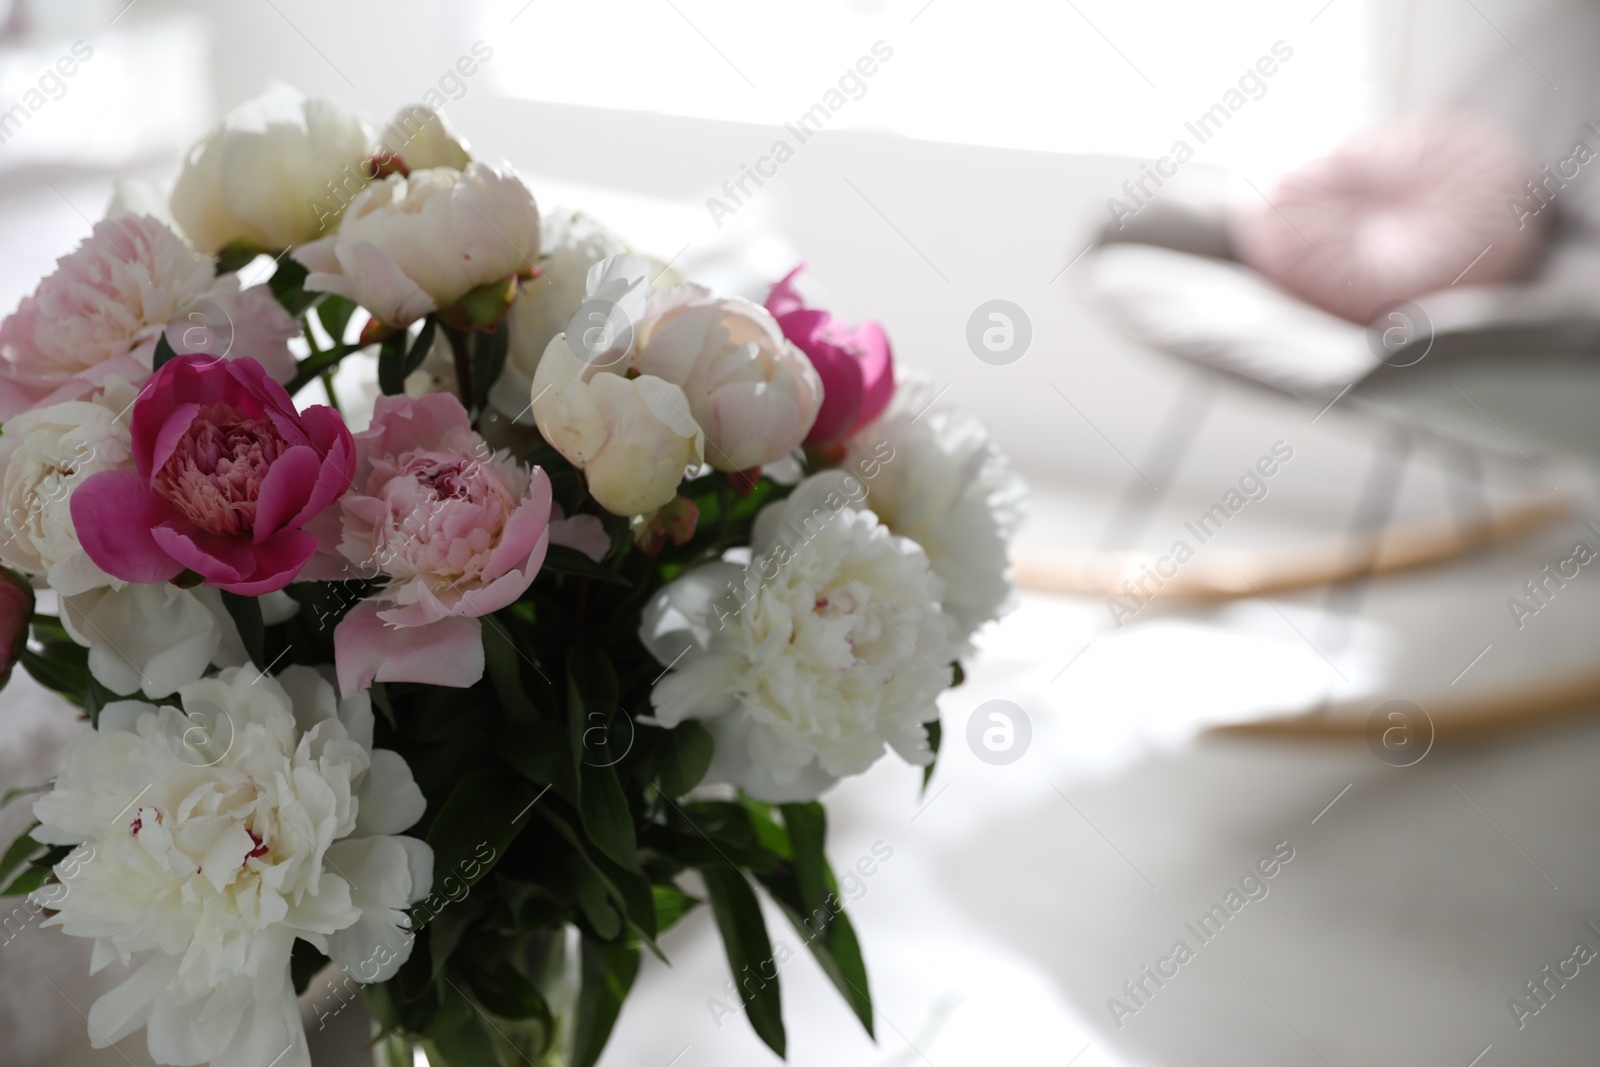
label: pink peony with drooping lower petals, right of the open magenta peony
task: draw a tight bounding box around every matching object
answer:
[307,394,550,696]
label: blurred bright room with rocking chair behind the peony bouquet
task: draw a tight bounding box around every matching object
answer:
[9,0,1600,1067]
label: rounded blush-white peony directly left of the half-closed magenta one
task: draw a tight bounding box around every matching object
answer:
[630,285,822,470]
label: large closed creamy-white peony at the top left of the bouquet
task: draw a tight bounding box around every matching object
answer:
[171,85,373,254]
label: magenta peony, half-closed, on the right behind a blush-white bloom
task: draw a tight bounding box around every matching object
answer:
[766,271,894,445]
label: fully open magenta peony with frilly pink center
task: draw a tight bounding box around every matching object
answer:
[72,355,355,597]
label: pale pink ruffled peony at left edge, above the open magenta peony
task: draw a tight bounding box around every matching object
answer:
[0,216,299,419]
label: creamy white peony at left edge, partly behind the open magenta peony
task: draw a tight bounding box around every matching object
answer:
[0,379,139,597]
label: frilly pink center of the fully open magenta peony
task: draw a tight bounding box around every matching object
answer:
[152,403,290,536]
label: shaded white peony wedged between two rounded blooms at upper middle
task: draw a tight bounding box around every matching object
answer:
[490,211,627,426]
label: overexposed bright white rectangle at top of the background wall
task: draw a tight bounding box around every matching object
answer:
[482,0,1376,171]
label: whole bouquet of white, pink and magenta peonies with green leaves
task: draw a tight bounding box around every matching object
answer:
[0,90,1021,1067]
